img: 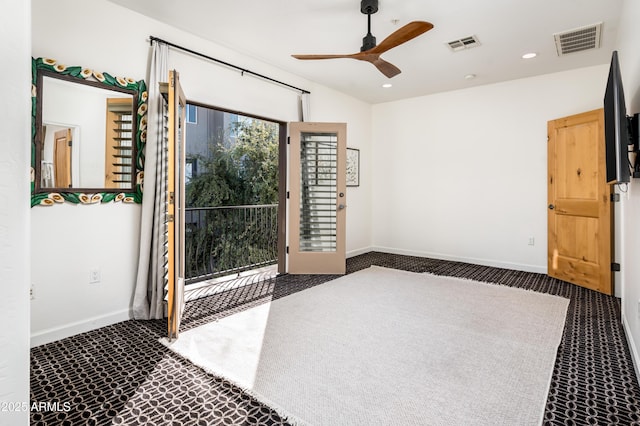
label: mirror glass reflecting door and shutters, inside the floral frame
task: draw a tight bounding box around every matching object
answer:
[36,75,136,190]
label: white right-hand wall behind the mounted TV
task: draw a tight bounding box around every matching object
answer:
[616,0,640,377]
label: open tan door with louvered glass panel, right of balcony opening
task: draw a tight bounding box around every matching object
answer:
[288,123,347,274]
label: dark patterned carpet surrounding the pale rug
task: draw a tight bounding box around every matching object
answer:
[31,252,640,425]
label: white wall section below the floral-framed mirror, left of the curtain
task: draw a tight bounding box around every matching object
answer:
[31,203,140,346]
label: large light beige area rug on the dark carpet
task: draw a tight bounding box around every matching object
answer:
[163,267,569,426]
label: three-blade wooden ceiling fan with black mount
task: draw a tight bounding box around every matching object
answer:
[291,0,433,78]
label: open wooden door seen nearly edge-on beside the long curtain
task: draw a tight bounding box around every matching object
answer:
[167,71,187,340]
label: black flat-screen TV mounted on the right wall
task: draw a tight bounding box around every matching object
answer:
[604,51,630,184]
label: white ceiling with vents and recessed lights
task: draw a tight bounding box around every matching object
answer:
[110,0,622,103]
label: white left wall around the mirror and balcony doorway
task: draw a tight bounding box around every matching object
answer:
[31,0,371,344]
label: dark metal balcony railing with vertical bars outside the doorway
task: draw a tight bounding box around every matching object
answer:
[185,204,278,283]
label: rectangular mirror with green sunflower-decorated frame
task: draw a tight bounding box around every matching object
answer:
[31,58,147,206]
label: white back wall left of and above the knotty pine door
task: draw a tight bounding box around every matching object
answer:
[372,65,608,273]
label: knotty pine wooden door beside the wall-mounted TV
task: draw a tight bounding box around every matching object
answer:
[547,109,613,294]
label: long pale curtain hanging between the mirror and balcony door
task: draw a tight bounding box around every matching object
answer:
[133,40,169,319]
